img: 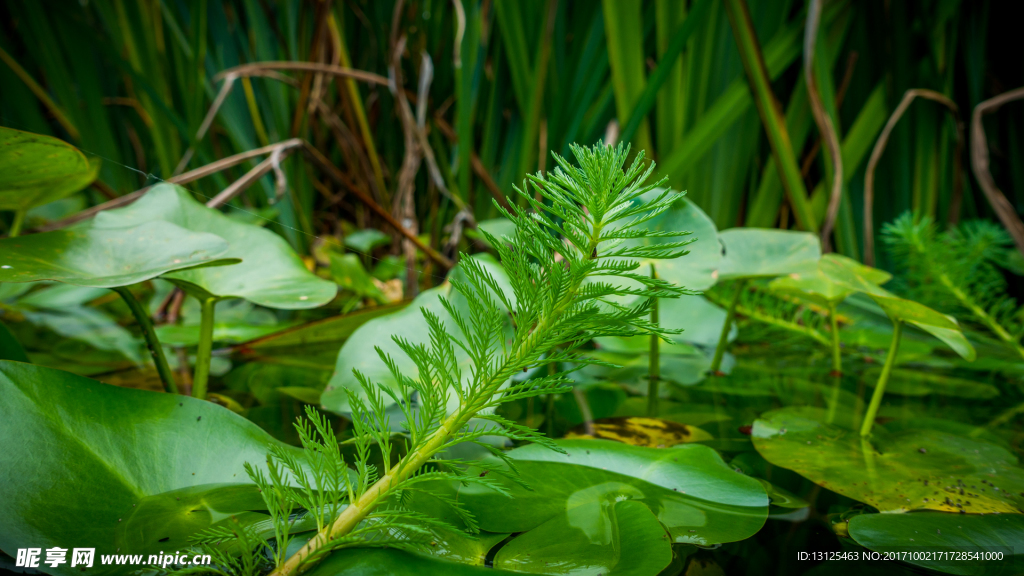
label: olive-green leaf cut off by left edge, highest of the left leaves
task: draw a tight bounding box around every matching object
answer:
[0,126,99,210]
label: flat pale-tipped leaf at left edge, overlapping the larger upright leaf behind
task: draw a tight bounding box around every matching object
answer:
[0,221,239,288]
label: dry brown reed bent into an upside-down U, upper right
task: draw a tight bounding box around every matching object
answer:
[864,88,964,266]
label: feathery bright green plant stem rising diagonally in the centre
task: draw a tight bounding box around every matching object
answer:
[200,142,690,576]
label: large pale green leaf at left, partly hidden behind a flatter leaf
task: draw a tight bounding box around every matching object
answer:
[92,184,337,310]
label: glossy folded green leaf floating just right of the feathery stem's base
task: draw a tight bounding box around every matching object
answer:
[459,440,768,545]
